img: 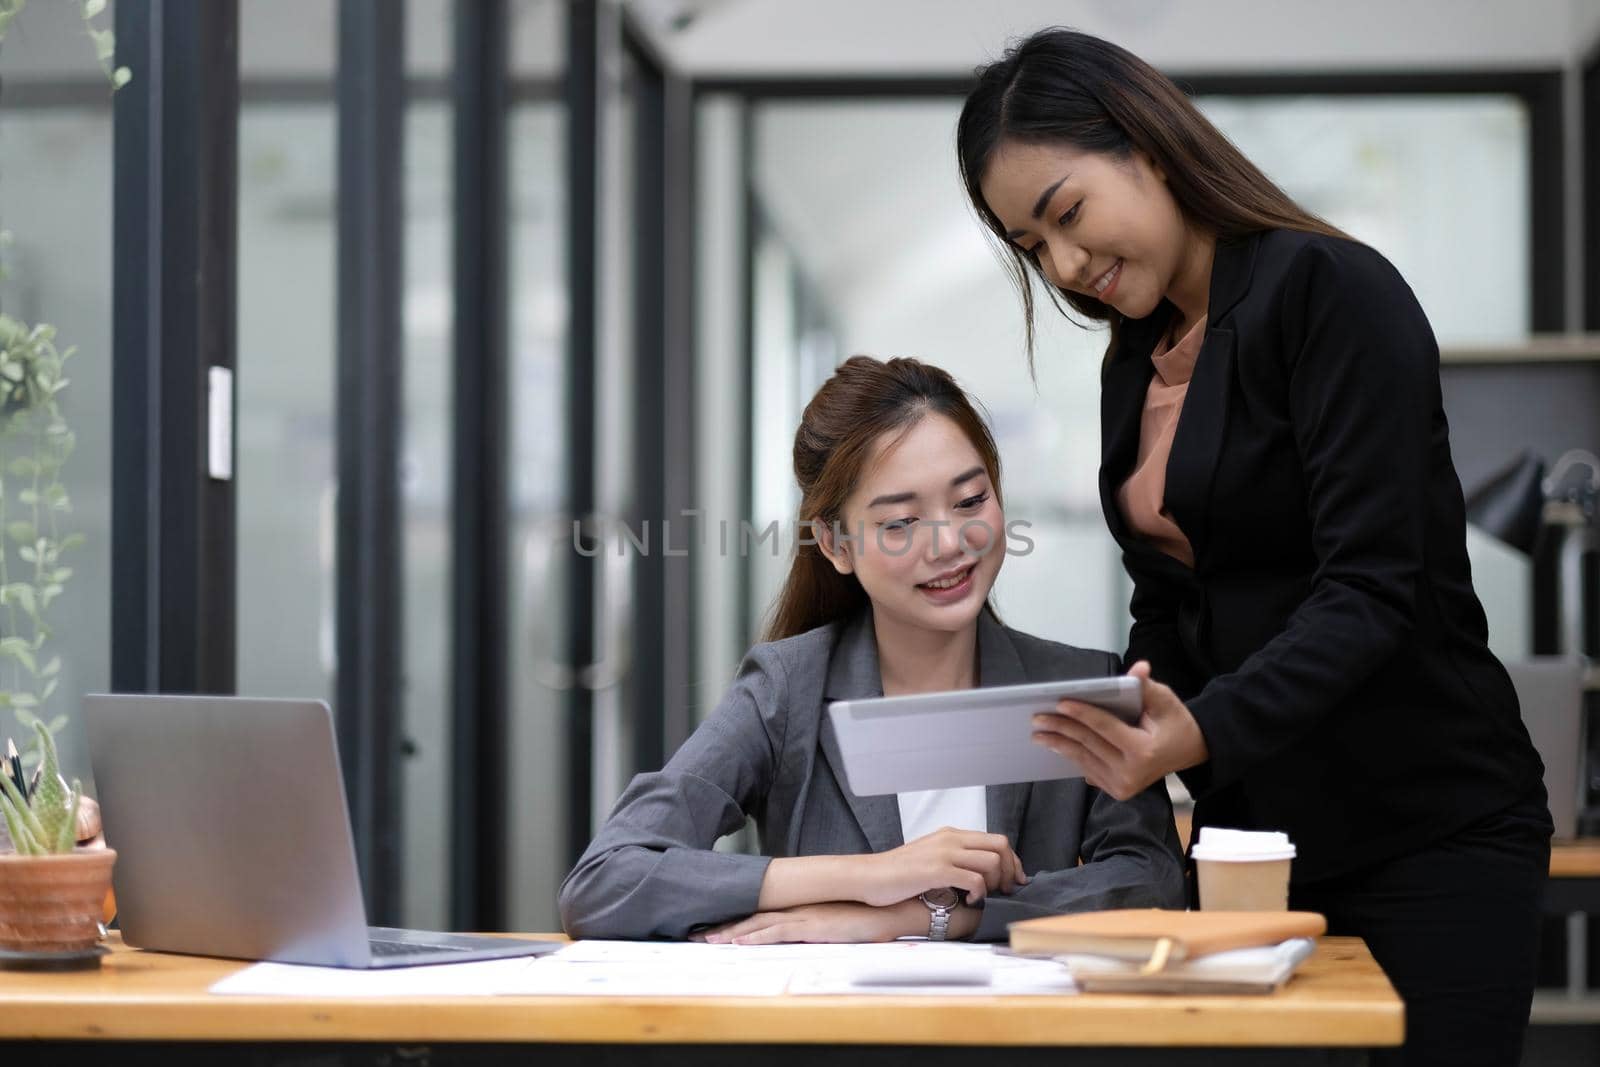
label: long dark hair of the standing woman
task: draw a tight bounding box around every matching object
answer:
[955,27,1349,371]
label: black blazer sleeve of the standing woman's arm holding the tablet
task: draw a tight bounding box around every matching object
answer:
[1182,242,1440,795]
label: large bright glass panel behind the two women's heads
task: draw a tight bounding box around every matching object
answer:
[723,88,1533,668]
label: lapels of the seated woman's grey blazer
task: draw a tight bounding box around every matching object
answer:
[819,608,1029,853]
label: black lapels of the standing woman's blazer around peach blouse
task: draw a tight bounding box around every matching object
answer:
[1099,234,1261,577]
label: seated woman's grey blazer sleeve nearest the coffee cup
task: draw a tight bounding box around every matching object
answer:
[973,654,1184,941]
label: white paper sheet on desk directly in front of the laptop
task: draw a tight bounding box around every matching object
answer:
[211,957,536,997]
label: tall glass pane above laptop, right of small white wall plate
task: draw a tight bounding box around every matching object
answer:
[235,99,338,704]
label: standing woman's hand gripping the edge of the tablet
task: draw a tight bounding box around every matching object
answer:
[1034,659,1211,800]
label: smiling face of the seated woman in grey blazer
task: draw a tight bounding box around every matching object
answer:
[819,414,1005,632]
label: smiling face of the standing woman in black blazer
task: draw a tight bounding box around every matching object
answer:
[979,141,1187,318]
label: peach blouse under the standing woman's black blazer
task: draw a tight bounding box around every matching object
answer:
[1117,317,1206,566]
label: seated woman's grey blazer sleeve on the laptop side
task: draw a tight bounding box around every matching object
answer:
[557,646,787,939]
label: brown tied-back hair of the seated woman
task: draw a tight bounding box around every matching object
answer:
[765,355,1003,641]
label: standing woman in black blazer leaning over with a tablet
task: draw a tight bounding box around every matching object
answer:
[957,30,1550,1065]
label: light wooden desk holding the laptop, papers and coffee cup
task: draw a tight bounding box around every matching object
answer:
[0,936,1403,1067]
